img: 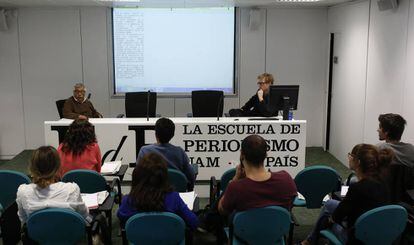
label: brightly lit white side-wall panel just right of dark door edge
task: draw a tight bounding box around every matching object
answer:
[328,1,369,163]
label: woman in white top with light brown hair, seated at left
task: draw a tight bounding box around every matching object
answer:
[16,146,90,223]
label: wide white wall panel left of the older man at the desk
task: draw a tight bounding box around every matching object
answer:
[19,8,82,148]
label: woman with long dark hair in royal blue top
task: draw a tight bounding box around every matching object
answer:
[117,153,198,230]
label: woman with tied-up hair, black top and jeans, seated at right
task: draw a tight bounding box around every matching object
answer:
[301,144,394,245]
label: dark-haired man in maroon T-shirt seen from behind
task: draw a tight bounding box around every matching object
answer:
[218,135,297,215]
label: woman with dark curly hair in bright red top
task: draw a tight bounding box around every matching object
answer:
[58,119,102,177]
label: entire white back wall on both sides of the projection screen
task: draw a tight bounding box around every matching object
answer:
[0,7,328,158]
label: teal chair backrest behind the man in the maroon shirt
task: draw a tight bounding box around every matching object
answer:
[233,206,291,245]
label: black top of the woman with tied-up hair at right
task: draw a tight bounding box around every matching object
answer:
[332,178,390,244]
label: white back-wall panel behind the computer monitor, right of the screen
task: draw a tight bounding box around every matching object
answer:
[265,8,329,146]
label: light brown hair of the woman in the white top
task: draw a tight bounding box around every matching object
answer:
[29,146,60,188]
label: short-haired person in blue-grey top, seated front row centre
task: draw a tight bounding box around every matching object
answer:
[137,118,195,190]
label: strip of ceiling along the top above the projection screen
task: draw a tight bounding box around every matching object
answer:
[0,0,352,8]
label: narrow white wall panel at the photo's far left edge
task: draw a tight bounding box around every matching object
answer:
[0,10,25,158]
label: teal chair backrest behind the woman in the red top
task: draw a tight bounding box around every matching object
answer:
[62,169,107,193]
